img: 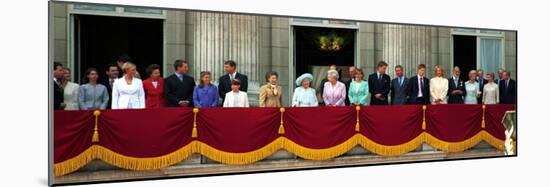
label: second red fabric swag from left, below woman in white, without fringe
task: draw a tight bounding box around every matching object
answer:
[98,108,193,157]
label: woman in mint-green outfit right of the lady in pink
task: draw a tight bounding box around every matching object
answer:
[348,69,369,106]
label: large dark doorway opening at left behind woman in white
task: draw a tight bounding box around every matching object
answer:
[74,15,163,81]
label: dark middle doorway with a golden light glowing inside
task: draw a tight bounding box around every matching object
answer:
[294,26,356,86]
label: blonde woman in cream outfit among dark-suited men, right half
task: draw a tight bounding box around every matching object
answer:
[430,65,449,104]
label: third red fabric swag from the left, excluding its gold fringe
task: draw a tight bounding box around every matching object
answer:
[197,108,280,153]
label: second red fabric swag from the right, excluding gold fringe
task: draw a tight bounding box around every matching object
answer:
[426,104,482,142]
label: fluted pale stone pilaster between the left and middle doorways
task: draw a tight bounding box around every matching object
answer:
[192,12,261,83]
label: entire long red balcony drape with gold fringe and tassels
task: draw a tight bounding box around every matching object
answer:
[54,105,515,175]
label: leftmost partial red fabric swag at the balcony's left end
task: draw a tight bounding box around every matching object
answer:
[53,110,95,163]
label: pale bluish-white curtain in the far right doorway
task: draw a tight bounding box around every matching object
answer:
[479,38,502,74]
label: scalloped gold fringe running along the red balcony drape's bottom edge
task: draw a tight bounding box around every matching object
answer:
[54,130,504,176]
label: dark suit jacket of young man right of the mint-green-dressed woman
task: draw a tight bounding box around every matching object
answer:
[368,72,391,105]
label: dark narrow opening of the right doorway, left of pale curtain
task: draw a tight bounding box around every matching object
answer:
[453,35,477,80]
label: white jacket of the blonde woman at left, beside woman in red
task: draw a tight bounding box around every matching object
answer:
[111,77,145,109]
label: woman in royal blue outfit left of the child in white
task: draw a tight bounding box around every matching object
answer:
[193,71,220,108]
